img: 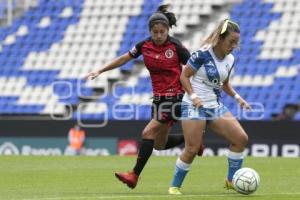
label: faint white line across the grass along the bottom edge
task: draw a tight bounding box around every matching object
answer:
[16,193,300,200]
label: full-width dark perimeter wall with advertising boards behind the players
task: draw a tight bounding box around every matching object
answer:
[0,120,300,157]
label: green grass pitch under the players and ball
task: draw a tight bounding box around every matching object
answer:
[0,156,300,200]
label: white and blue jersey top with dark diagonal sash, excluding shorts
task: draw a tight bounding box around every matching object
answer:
[183,48,234,108]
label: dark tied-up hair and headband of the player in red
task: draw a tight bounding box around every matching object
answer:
[148,4,177,30]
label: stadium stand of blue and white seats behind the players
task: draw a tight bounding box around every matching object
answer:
[0,0,300,120]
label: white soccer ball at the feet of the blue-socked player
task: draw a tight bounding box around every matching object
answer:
[232,167,260,194]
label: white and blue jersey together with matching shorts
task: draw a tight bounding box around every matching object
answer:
[181,48,234,120]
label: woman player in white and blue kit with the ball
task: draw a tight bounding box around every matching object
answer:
[169,19,251,194]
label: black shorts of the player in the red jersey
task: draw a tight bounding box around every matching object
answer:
[151,94,183,126]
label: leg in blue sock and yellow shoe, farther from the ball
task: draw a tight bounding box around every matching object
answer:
[169,120,206,194]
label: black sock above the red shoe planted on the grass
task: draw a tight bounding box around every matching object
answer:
[133,139,154,176]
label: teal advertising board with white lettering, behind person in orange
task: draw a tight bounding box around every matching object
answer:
[0,137,117,156]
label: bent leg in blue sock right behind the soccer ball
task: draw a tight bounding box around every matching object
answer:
[209,112,248,188]
